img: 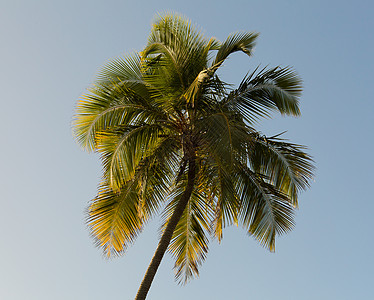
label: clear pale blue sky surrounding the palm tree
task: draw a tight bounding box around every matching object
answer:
[0,0,374,300]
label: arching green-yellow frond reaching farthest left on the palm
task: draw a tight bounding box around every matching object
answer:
[73,56,165,151]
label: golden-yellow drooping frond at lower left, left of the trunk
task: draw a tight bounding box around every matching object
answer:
[88,138,180,256]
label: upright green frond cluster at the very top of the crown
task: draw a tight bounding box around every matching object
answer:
[142,15,218,101]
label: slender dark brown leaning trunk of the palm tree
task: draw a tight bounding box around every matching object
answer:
[135,158,196,300]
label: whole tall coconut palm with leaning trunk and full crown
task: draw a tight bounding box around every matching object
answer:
[73,14,313,300]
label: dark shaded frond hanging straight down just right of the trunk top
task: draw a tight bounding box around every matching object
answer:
[196,106,249,241]
